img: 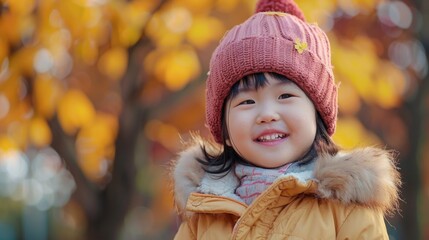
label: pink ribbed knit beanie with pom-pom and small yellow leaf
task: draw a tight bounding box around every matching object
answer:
[206,0,338,143]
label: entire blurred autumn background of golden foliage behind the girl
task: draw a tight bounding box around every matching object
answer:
[0,0,429,240]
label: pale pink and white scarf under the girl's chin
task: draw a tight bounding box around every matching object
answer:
[235,164,290,205]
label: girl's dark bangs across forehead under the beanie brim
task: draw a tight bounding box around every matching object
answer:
[228,73,290,99]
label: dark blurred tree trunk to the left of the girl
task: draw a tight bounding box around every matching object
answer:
[87,102,142,240]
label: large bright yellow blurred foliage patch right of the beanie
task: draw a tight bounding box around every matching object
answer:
[332,37,405,108]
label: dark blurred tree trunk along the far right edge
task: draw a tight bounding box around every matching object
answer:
[399,0,429,239]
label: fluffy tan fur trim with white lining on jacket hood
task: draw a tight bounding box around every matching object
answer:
[172,137,401,217]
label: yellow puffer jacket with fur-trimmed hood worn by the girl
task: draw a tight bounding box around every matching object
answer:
[173,138,400,240]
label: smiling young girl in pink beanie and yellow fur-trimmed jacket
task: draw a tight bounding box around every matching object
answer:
[173,0,400,239]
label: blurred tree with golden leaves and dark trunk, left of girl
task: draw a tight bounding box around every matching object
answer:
[0,0,247,239]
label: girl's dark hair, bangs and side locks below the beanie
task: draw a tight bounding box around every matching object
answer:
[197,73,340,177]
